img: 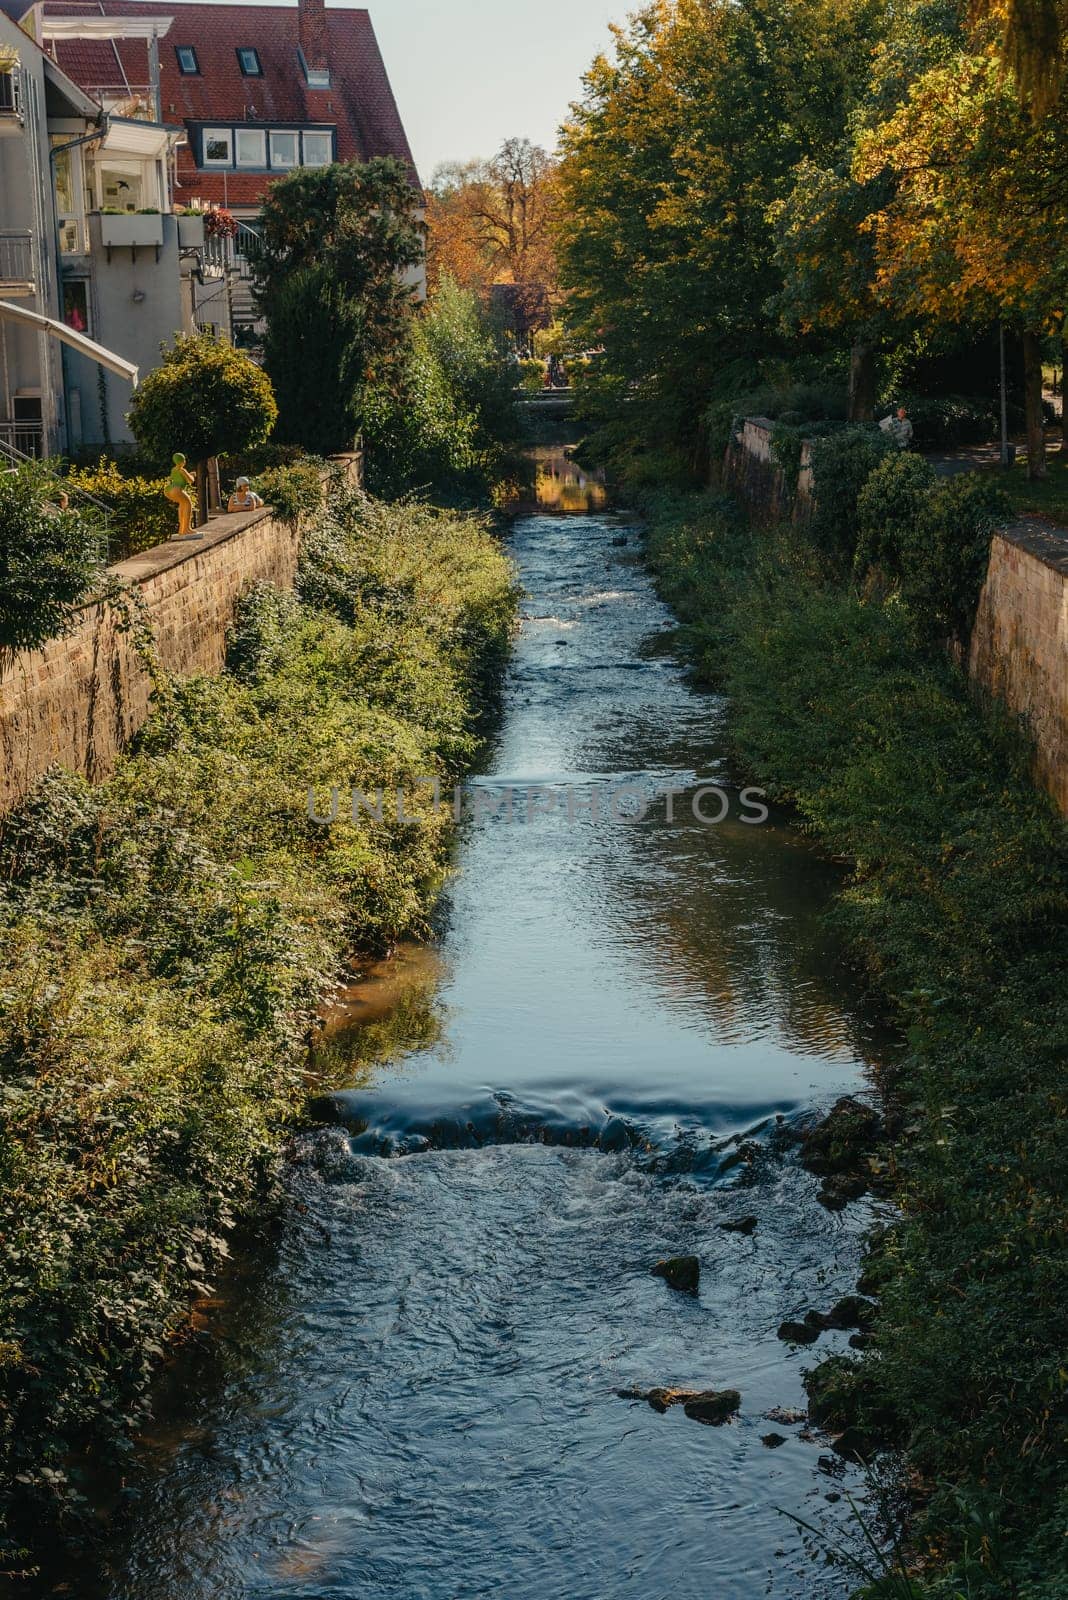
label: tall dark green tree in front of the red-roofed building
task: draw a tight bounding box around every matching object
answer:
[254,157,424,450]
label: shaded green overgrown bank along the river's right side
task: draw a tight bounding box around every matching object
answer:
[646,494,1068,1600]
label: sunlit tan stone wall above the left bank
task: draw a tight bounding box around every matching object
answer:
[0,456,363,811]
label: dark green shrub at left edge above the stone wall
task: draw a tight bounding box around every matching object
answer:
[0,464,106,670]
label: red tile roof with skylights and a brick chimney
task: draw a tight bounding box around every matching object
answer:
[46,0,419,206]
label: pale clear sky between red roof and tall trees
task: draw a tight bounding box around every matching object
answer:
[370,0,626,182]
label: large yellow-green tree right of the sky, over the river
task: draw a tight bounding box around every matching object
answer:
[558,0,879,464]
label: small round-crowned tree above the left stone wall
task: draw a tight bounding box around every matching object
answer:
[128,333,278,514]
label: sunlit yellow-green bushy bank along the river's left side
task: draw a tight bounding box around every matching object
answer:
[0,494,516,1573]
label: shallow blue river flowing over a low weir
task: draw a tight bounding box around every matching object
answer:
[87,492,878,1600]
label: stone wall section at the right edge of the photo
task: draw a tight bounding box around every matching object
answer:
[969,520,1068,813]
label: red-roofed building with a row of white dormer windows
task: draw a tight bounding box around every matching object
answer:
[24,0,425,339]
